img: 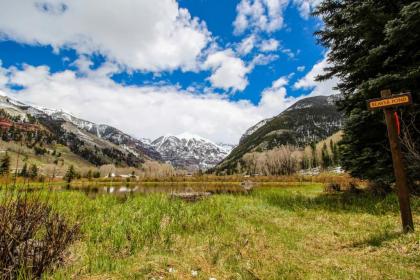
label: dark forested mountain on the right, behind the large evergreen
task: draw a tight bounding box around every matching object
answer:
[215,95,343,172]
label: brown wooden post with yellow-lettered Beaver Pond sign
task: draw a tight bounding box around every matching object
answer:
[368,90,414,233]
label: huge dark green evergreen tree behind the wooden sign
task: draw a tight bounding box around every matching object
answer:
[315,0,420,186]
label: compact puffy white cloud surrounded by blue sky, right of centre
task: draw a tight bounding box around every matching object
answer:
[204,49,251,91]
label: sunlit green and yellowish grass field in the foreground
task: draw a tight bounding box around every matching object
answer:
[19,184,420,279]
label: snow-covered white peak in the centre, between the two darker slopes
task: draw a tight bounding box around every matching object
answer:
[151,133,233,170]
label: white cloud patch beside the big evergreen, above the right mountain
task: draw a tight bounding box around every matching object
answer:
[293,54,339,95]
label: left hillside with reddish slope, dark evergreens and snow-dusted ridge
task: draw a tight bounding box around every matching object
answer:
[0,97,160,167]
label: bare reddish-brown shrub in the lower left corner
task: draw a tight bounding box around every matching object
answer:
[0,192,79,279]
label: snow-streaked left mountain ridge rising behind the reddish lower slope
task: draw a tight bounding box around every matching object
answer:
[0,96,162,164]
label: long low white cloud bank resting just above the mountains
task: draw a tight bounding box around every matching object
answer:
[0,65,306,143]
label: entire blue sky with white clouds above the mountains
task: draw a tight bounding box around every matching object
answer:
[0,0,336,143]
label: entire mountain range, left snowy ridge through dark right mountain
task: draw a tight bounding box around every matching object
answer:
[0,95,343,171]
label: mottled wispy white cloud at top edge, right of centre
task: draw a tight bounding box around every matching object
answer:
[233,0,289,35]
